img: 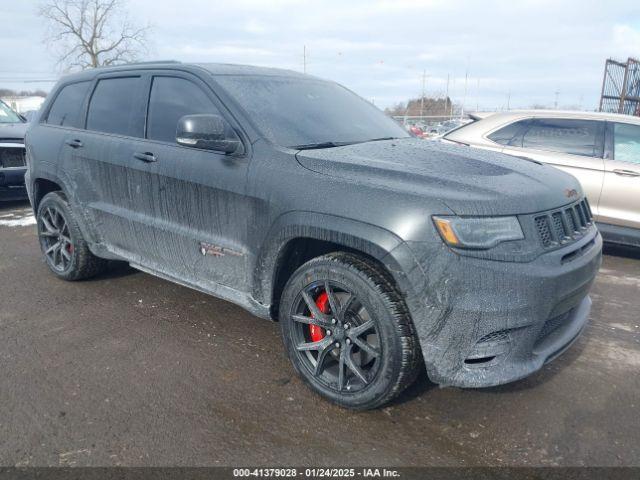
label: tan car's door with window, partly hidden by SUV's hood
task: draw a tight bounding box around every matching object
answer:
[503,118,605,215]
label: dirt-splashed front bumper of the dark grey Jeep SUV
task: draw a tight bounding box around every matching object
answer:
[408,227,602,387]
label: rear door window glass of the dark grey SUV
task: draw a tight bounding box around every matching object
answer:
[87,77,144,137]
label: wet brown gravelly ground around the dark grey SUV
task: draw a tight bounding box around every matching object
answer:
[0,203,640,466]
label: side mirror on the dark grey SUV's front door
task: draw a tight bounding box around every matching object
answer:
[176,114,242,153]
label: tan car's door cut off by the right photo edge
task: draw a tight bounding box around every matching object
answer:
[599,122,640,228]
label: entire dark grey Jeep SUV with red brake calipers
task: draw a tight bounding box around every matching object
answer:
[27,63,602,409]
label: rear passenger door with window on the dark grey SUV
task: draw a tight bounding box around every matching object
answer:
[76,73,145,255]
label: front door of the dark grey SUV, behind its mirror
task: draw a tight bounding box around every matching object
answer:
[129,72,254,291]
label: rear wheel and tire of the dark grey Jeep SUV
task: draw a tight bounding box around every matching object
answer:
[37,192,107,281]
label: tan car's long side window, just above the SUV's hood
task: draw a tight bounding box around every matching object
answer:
[522,118,604,157]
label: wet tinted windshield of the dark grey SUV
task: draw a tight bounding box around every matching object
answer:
[216,75,410,148]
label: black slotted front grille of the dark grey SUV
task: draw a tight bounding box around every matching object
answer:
[534,198,593,248]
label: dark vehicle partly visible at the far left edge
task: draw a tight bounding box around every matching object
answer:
[0,100,27,201]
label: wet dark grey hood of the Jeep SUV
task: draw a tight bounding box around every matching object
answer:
[297,138,582,215]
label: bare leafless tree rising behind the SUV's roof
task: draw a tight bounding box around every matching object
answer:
[38,0,149,69]
